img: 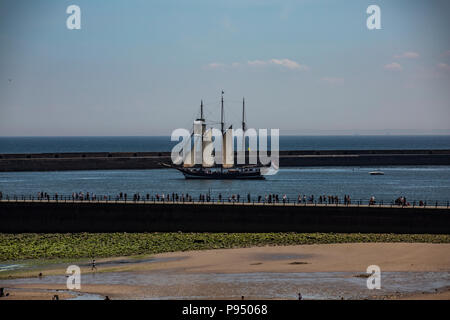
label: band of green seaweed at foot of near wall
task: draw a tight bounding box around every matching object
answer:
[0,232,450,261]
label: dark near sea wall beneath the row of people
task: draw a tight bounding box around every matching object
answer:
[0,201,450,234]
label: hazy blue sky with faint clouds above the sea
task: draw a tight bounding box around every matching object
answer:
[0,0,450,136]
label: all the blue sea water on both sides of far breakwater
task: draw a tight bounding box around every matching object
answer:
[0,135,450,204]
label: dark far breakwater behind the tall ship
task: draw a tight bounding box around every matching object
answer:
[0,150,450,172]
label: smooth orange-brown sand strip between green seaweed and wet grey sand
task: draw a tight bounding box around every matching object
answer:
[133,243,450,273]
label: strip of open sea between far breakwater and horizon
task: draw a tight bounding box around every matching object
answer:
[0,135,450,154]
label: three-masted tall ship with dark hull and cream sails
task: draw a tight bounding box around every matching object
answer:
[163,91,265,180]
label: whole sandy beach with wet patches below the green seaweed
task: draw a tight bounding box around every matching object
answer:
[0,243,450,299]
